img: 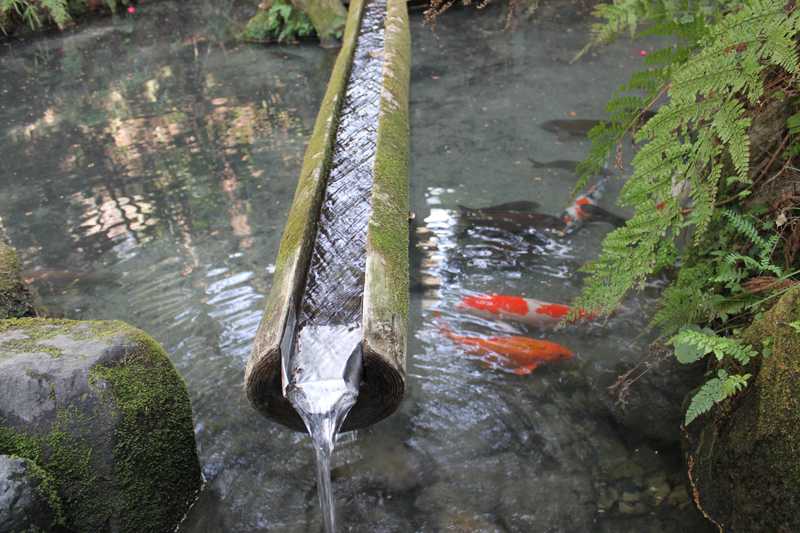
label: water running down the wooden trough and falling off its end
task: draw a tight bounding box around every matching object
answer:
[283,0,386,533]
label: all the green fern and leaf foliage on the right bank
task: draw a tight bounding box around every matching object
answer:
[575,0,800,424]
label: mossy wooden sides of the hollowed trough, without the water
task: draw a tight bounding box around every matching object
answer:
[245,0,410,431]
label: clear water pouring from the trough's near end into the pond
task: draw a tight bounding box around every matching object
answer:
[282,326,362,533]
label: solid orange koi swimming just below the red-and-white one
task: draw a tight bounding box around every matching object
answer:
[441,324,574,376]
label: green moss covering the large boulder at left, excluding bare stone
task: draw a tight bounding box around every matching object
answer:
[0,319,202,532]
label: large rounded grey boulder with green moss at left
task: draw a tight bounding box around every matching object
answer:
[0,318,202,533]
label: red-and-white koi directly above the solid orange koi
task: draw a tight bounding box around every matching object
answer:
[456,294,594,327]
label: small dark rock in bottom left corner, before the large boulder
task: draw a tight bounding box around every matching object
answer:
[0,455,64,532]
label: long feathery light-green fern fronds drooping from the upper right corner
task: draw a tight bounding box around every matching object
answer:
[576,0,800,312]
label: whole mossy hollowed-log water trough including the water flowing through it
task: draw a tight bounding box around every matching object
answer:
[245,0,410,531]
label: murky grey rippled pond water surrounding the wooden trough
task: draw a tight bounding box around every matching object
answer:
[0,0,708,533]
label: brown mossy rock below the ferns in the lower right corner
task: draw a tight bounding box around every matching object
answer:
[687,288,800,533]
